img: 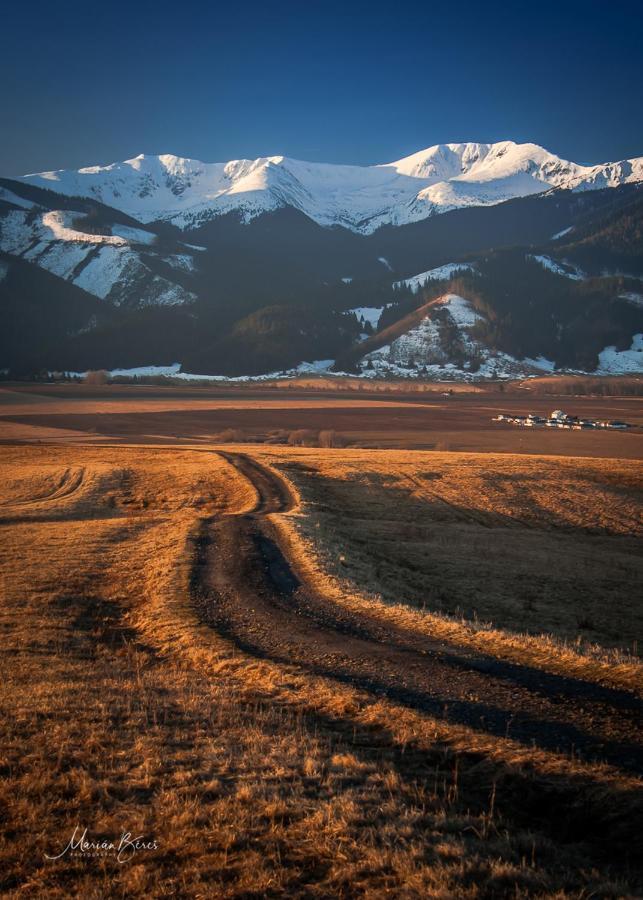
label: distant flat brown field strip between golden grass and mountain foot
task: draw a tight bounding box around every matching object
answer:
[0,382,643,459]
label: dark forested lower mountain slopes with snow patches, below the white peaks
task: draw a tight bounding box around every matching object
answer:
[0,165,643,379]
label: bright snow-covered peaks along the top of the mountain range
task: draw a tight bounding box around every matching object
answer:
[23,141,643,234]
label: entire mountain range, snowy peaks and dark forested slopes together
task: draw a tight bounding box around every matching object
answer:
[0,141,643,378]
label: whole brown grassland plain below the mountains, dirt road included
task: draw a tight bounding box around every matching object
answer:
[0,385,643,898]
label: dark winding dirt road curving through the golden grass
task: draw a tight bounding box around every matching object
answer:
[193,453,643,774]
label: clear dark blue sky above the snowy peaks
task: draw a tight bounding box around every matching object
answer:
[0,0,643,175]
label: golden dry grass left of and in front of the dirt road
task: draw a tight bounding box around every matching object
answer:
[0,447,637,898]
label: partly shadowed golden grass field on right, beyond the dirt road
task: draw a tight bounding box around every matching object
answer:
[249,448,643,691]
